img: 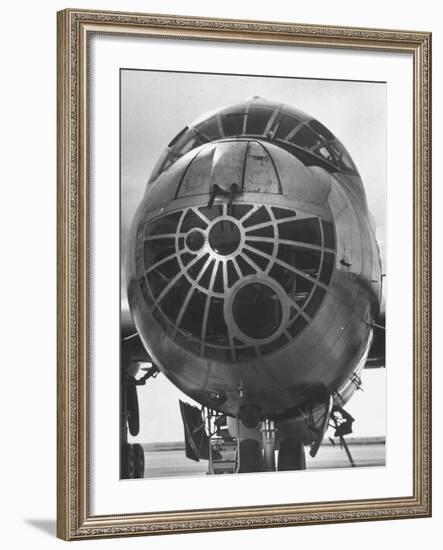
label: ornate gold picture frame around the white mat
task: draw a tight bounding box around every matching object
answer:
[57,9,431,540]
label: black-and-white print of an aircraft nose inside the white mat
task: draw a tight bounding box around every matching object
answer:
[119,68,387,479]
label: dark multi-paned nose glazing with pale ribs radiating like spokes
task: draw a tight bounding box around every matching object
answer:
[137,203,335,362]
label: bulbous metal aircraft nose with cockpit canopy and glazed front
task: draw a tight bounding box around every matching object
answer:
[127,98,382,452]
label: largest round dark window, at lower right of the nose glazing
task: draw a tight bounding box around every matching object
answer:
[232,283,283,340]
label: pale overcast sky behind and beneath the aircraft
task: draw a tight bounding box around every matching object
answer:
[121,70,386,442]
